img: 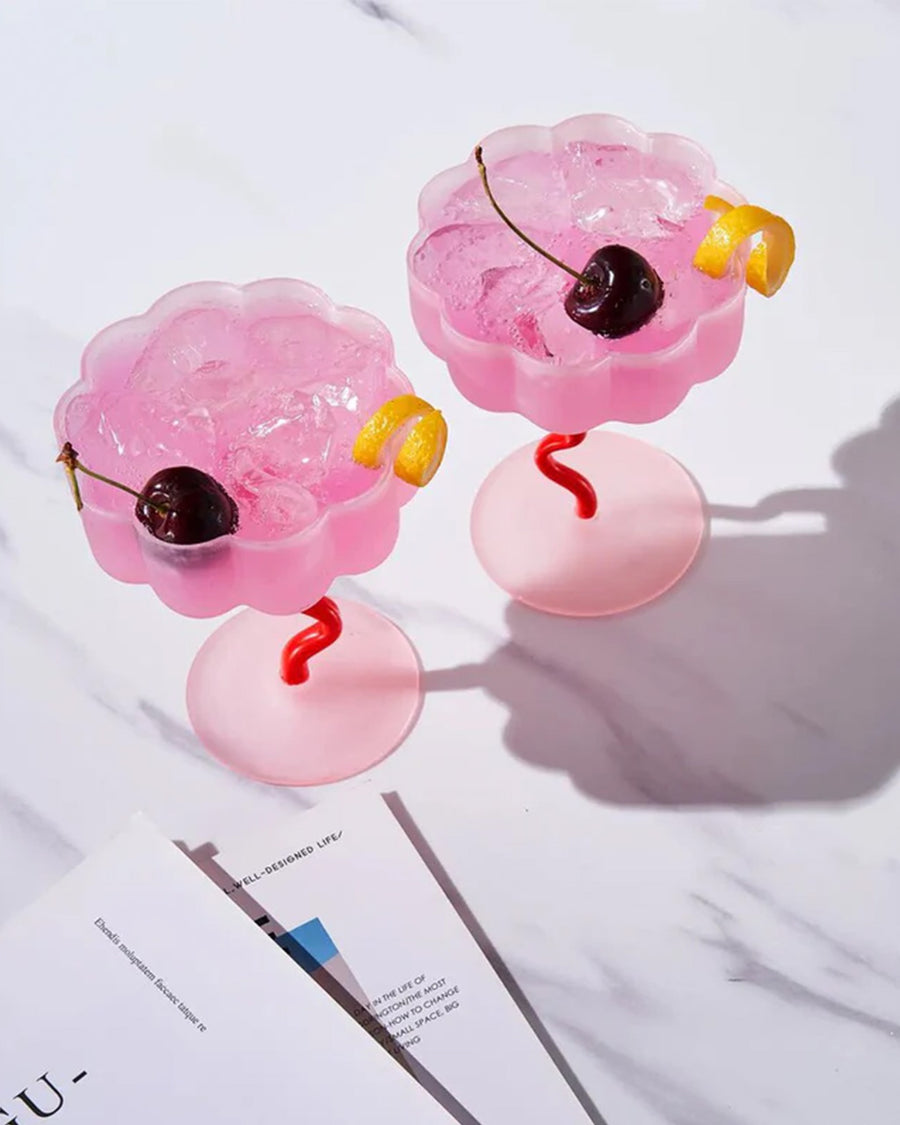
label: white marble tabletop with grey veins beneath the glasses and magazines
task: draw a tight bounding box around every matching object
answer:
[0,0,900,1125]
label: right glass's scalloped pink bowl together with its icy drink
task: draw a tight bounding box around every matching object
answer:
[407,115,747,433]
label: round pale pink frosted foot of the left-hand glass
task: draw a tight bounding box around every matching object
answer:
[188,602,421,785]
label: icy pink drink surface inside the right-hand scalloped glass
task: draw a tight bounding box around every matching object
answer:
[412,141,744,366]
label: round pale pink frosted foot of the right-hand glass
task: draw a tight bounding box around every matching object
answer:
[471,432,707,618]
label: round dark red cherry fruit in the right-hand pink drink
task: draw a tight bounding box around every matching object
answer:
[566,246,663,340]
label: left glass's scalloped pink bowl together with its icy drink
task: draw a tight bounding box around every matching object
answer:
[54,279,412,617]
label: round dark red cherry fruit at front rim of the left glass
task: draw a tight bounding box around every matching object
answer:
[134,465,237,543]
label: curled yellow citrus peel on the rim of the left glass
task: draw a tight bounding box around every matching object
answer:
[353,395,447,488]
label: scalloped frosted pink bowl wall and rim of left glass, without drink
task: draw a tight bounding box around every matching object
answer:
[54,279,413,618]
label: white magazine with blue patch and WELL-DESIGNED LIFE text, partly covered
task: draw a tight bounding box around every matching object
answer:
[206,786,591,1125]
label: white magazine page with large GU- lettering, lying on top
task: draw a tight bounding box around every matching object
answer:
[0,819,451,1125]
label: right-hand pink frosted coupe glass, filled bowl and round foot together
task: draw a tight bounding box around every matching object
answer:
[407,115,746,617]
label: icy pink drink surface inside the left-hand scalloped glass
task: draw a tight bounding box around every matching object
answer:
[64,308,388,540]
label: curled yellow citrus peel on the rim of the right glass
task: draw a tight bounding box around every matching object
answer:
[694,196,794,297]
